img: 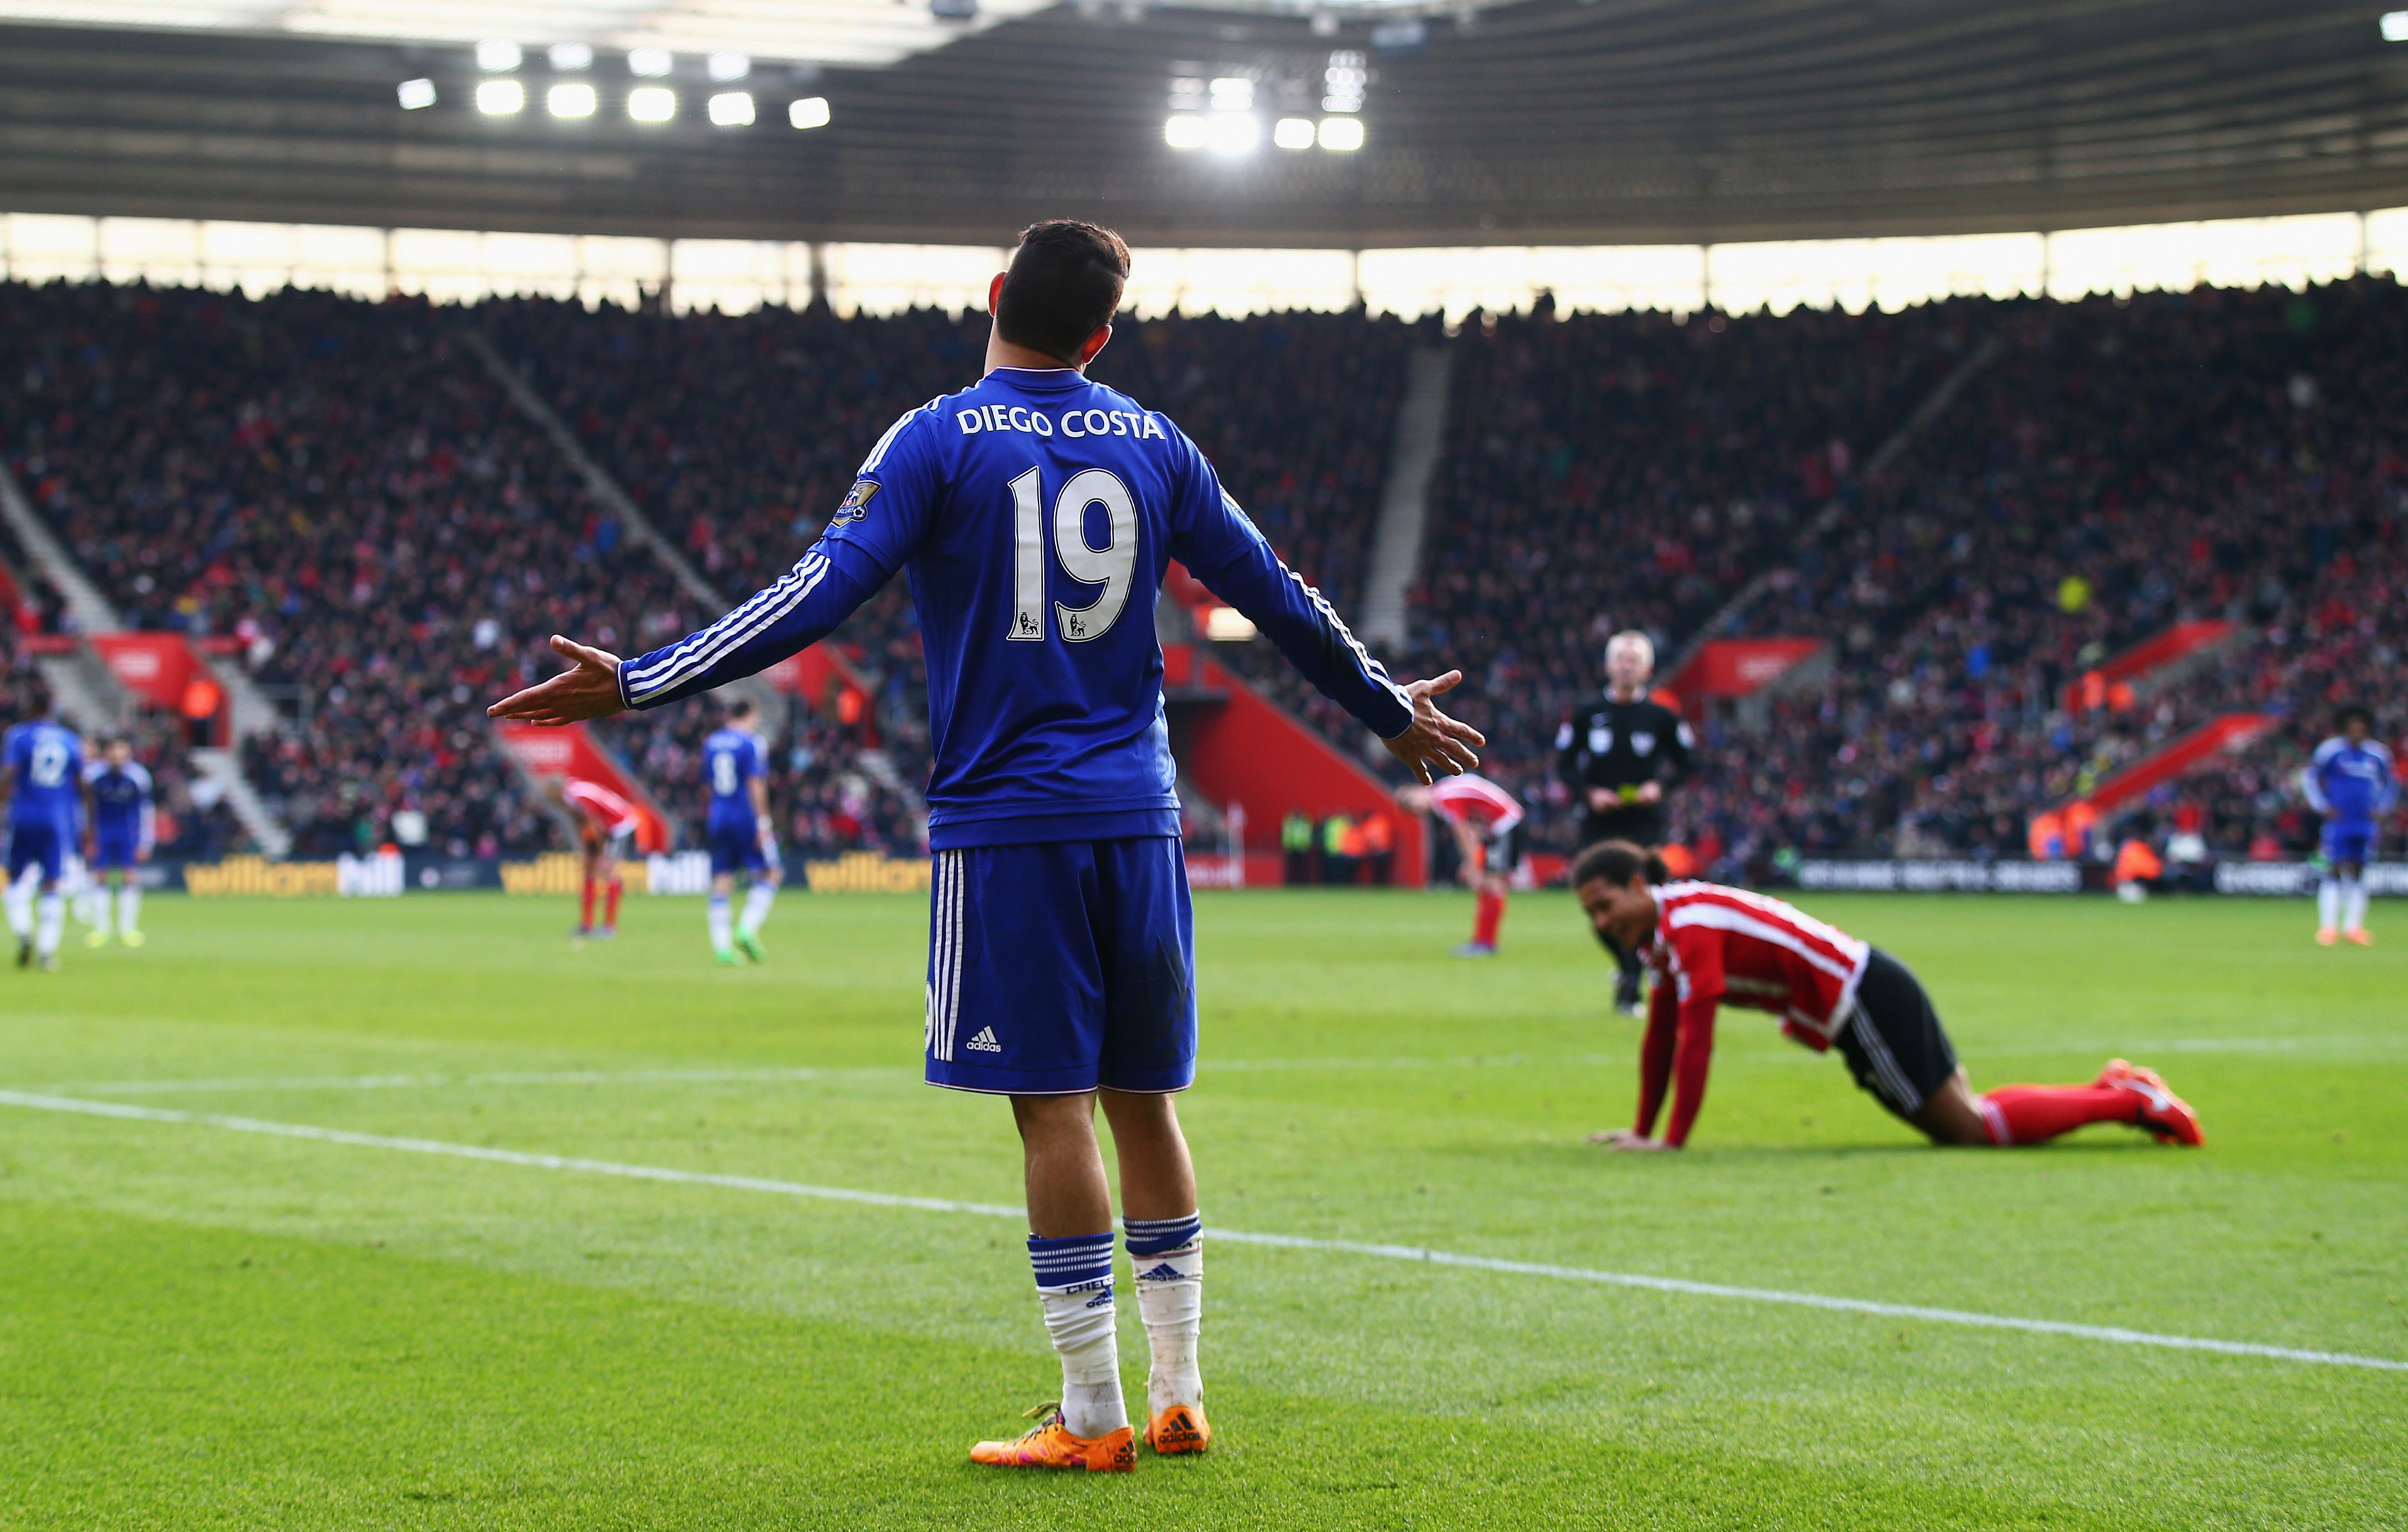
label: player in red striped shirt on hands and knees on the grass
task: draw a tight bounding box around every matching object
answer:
[1573,840,2206,1149]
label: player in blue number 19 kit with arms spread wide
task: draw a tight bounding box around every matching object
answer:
[491,219,1486,1472]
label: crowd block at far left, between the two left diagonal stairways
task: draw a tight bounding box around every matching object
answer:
[0,284,686,855]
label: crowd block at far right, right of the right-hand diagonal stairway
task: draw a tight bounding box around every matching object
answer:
[1688,279,2408,855]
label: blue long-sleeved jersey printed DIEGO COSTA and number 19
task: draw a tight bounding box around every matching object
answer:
[619,369,1413,850]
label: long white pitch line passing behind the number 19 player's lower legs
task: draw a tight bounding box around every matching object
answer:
[0,1091,2408,1373]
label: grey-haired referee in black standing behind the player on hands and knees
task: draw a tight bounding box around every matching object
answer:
[1556,628,1698,1016]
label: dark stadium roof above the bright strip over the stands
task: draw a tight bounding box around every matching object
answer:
[0,0,2408,248]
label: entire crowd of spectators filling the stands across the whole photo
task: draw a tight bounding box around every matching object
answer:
[0,279,2408,872]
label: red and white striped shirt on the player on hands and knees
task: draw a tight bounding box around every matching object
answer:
[1637,882,1873,1144]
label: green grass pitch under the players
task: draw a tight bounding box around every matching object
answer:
[0,894,2408,1532]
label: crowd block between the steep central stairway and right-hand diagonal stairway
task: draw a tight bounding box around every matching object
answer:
[1406,304,1977,850]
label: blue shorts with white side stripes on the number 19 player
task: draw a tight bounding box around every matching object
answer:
[927,836,1197,1096]
